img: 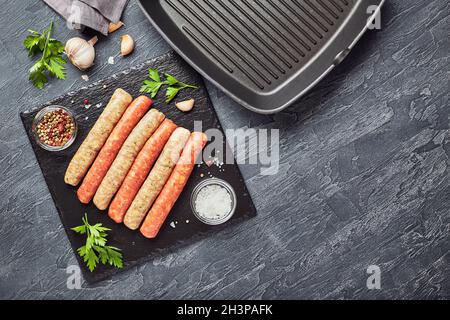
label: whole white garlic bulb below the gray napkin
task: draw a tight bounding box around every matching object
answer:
[65,37,98,70]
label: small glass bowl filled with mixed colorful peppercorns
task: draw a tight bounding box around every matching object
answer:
[31,105,77,151]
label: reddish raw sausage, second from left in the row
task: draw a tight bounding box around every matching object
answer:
[77,96,152,203]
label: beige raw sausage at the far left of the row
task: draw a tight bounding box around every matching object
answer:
[64,89,133,186]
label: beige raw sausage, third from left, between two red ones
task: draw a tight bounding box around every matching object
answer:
[94,109,165,210]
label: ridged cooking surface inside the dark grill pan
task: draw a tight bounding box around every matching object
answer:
[164,0,353,91]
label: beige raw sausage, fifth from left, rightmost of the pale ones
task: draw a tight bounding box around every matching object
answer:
[124,128,190,230]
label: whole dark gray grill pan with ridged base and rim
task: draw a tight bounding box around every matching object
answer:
[139,0,384,114]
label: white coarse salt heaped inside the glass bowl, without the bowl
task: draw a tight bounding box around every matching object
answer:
[195,184,232,220]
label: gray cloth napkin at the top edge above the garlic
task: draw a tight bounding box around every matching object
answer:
[44,0,128,35]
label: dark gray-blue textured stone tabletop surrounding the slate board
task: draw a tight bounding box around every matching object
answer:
[0,0,450,299]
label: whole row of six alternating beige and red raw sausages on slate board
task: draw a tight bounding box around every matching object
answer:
[64,89,207,238]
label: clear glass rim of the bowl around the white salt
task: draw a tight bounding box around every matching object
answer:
[191,178,237,226]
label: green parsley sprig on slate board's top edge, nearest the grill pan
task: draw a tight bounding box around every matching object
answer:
[140,69,198,103]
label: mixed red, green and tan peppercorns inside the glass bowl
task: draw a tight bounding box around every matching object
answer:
[36,109,75,147]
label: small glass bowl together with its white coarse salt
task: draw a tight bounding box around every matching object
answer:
[191,178,236,225]
